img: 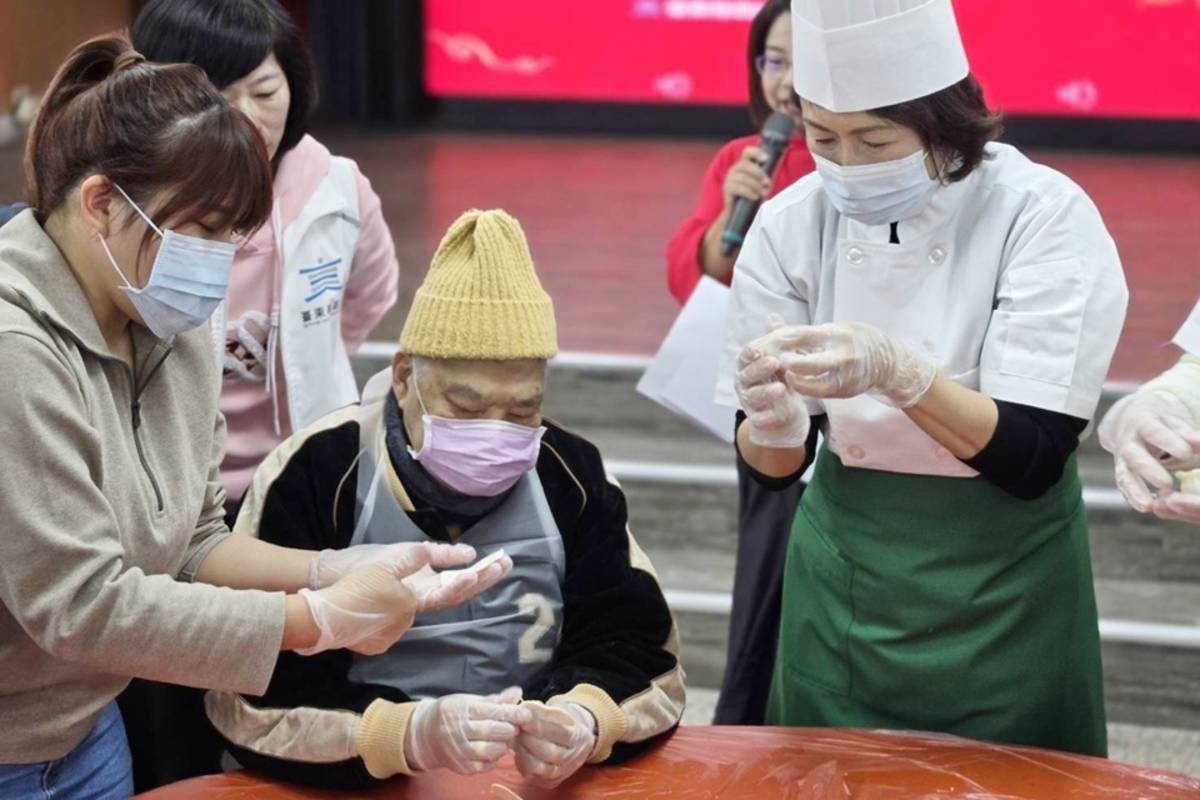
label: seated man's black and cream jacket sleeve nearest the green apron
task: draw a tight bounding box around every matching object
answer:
[523,429,684,763]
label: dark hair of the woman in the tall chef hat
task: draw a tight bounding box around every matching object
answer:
[871,74,1004,184]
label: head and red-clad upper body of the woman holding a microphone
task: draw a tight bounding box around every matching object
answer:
[667,0,814,303]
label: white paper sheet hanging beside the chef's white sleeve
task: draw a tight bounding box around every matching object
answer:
[637,276,733,443]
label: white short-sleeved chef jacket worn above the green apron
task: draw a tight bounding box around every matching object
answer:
[716,143,1129,477]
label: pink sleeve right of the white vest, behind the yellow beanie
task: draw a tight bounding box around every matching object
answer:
[342,166,400,353]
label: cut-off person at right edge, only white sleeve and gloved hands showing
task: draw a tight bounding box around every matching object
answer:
[1099,303,1200,525]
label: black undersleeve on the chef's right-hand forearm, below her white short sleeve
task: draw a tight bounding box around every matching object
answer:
[962,401,1087,500]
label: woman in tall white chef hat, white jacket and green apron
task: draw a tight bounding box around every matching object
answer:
[719,0,1128,754]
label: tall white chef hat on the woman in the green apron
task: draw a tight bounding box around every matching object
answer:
[792,0,970,112]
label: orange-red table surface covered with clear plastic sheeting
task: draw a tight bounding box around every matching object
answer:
[142,727,1200,800]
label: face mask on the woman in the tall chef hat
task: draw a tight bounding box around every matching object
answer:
[812,150,938,225]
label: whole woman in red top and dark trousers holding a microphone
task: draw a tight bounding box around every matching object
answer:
[667,0,814,724]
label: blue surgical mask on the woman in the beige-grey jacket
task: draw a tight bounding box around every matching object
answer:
[100,184,238,339]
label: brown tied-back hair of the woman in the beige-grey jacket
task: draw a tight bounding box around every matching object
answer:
[25,36,271,240]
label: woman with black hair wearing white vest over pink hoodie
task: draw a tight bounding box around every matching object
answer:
[132,0,400,527]
